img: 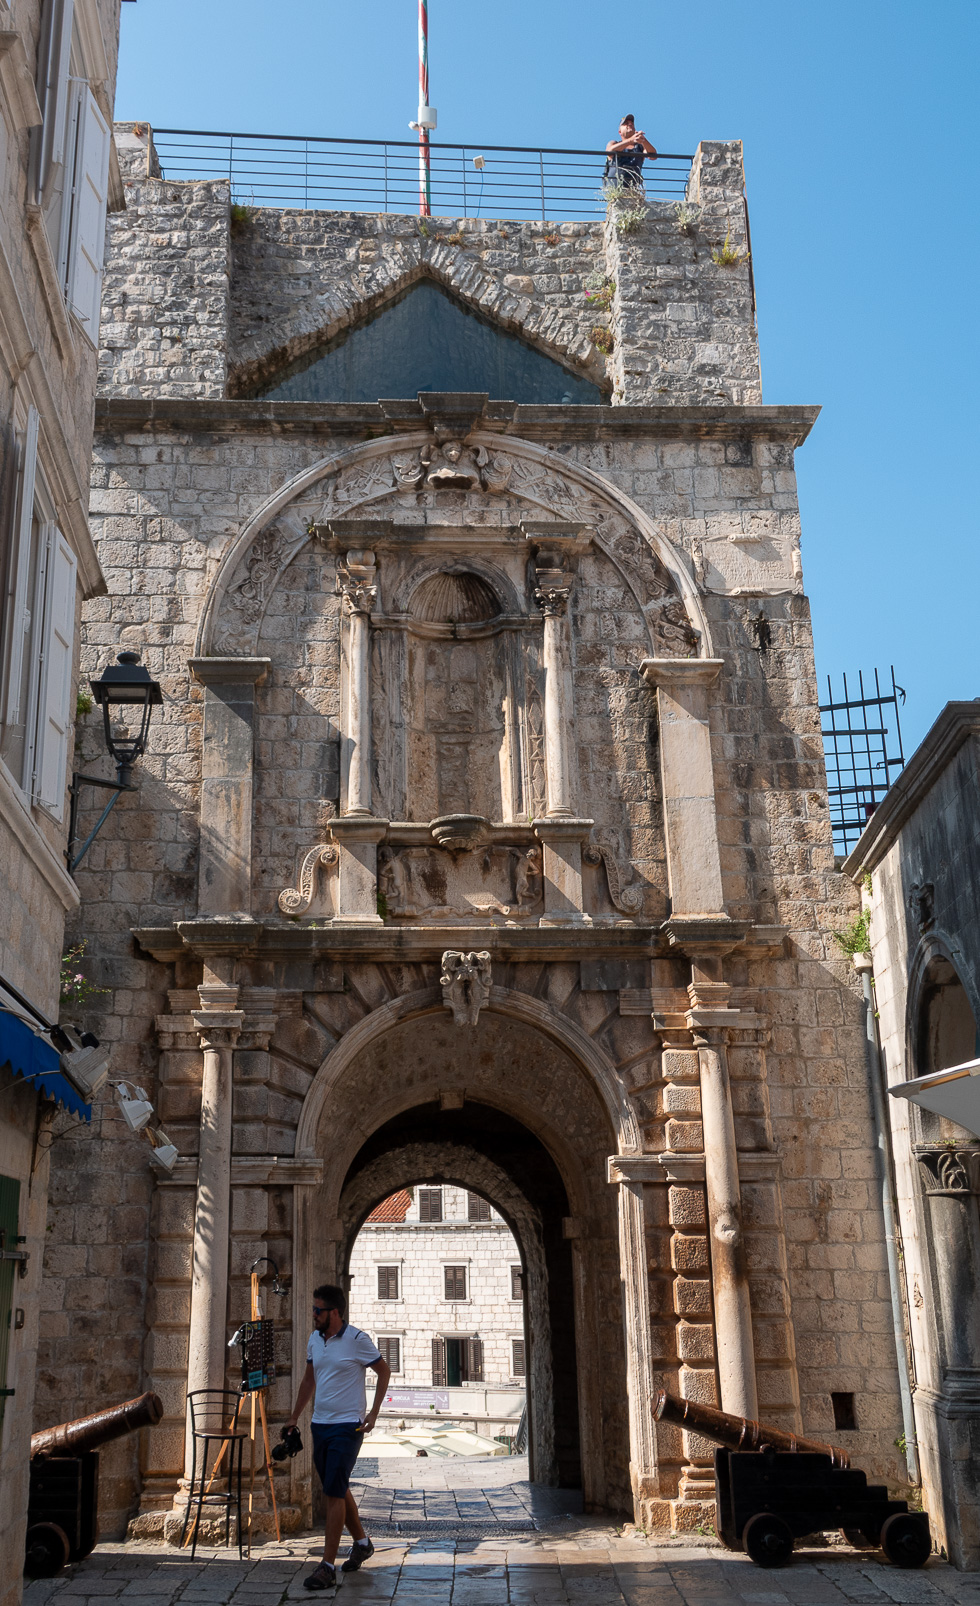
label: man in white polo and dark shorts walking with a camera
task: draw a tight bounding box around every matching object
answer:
[283,1283,392,1590]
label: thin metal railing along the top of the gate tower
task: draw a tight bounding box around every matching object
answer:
[153,128,692,223]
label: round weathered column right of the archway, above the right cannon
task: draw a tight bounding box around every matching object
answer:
[688,1009,758,1418]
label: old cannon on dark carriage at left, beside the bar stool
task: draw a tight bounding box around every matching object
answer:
[24,1394,164,1579]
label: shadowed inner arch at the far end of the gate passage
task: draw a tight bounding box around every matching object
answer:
[337,1140,555,1484]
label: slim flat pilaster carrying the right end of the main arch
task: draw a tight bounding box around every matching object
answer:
[607,1155,664,1527]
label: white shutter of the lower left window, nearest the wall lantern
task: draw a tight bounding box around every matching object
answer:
[34,525,77,819]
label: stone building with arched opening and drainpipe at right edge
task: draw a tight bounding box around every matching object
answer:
[845,702,980,1569]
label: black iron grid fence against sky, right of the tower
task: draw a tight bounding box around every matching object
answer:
[819,668,904,856]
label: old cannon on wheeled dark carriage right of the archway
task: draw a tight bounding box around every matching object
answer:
[654,1389,932,1567]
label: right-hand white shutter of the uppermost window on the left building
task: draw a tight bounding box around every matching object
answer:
[66,82,109,345]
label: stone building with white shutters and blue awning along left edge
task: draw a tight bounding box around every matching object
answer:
[0,0,122,1606]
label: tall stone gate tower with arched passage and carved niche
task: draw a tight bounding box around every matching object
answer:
[42,130,900,1527]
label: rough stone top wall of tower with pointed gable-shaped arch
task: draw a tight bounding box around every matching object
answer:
[100,134,762,406]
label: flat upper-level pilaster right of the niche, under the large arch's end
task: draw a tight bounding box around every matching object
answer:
[639,658,725,919]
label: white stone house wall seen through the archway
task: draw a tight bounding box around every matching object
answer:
[350,1187,524,1388]
